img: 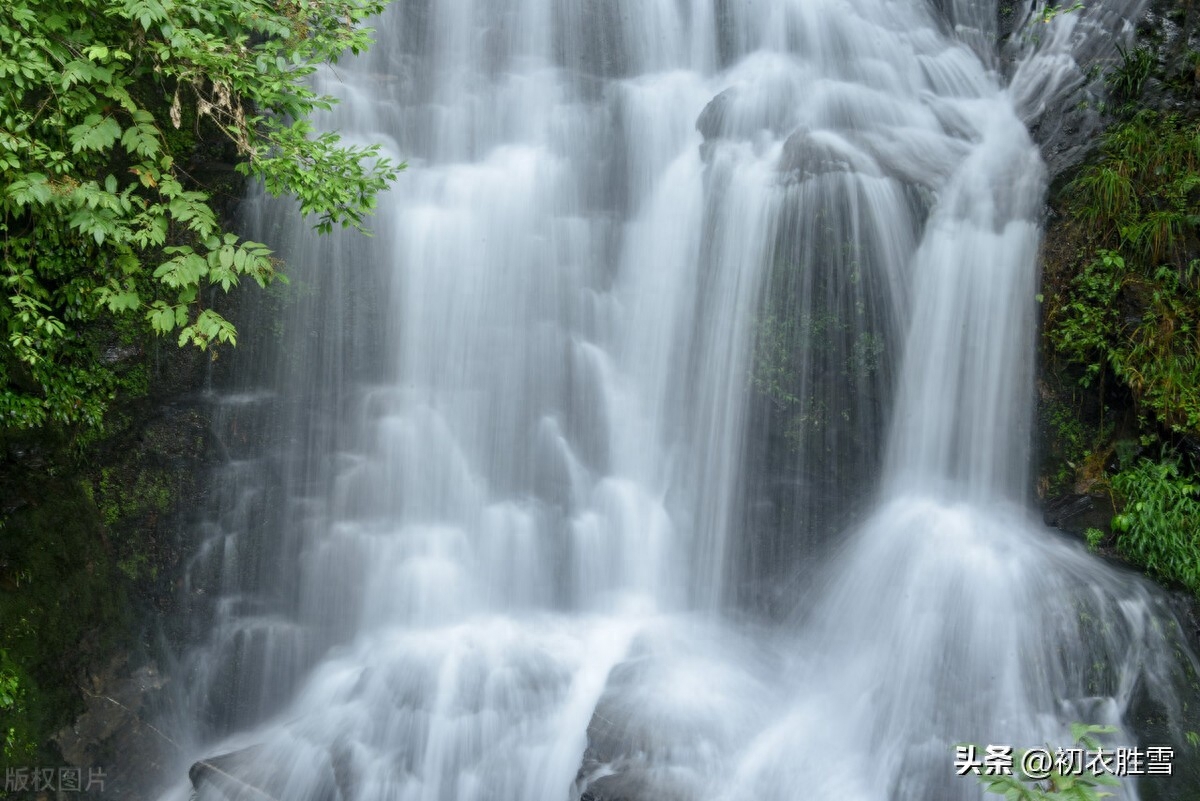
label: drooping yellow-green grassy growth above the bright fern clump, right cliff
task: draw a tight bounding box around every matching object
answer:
[1046,110,1200,434]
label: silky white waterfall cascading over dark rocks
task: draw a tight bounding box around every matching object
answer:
[154,0,1195,801]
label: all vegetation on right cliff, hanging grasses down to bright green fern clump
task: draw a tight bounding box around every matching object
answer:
[1043,23,1200,594]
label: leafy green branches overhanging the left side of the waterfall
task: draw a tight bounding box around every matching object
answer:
[0,0,403,429]
